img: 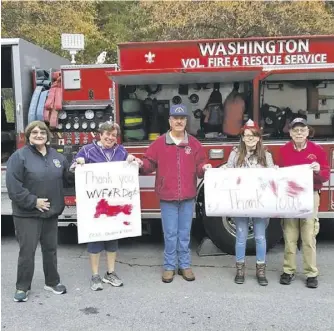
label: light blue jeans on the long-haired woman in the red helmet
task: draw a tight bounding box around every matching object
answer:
[234,217,268,263]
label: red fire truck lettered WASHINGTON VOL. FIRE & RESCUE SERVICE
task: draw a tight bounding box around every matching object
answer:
[4,35,334,254]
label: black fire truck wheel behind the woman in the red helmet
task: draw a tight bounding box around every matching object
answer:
[197,188,283,255]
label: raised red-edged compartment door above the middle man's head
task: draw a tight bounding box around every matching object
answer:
[107,67,261,85]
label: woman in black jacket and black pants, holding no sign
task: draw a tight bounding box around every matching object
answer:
[6,121,73,302]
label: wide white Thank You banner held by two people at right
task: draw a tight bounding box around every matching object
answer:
[204,165,313,218]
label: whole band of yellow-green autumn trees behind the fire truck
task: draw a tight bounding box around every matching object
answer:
[1,1,334,63]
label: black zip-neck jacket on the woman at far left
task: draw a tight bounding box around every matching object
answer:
[6,145,73,218]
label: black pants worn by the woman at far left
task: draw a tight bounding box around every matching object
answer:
[14,216,60,291]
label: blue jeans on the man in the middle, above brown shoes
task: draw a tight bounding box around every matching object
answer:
[160,199,195,270]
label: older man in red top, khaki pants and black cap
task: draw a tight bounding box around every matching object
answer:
[279,118,330,288]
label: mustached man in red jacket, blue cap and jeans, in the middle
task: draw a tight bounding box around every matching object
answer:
[137,105,211,283]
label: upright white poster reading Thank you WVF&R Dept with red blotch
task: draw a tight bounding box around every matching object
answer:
[75,162,141,243]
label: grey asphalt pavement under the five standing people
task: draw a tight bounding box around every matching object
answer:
[1,224,334,331]
